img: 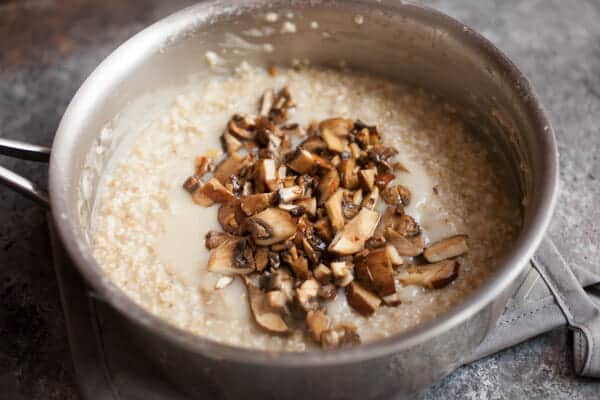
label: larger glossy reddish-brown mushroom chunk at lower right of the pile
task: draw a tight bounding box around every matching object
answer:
[354,248,396,297]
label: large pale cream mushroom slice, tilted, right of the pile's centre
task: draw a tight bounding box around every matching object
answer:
[329,208,379,255]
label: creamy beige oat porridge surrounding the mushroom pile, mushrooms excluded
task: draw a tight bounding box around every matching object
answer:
[92,68,521,351]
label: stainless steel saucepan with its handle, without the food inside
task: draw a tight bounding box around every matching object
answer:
[0,0,558,399]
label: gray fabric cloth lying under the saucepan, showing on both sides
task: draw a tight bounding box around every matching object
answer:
[53,223,600,400]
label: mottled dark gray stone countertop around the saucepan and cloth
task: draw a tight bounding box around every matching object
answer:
[0,0,600,400]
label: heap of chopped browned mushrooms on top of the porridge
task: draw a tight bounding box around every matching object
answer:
[183,87,468,349]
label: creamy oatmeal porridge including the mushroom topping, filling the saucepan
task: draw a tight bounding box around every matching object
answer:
[92,68,521,351]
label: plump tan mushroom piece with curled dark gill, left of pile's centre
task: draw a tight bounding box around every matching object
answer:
[247,208,296,246]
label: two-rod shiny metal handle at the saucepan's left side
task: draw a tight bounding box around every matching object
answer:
[0,138,50,207]
